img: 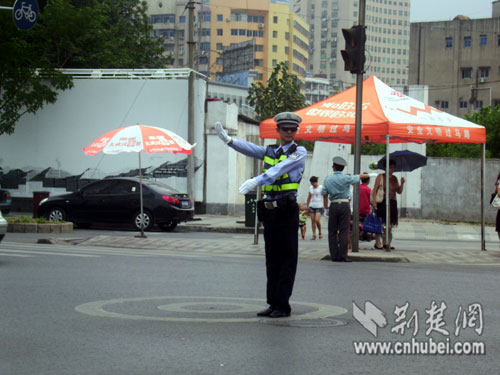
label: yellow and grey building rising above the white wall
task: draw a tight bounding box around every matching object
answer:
[148,0,309,85]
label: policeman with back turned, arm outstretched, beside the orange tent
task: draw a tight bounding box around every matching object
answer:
[322,156,369,262]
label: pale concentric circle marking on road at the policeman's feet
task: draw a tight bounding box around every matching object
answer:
[75,296,347,323]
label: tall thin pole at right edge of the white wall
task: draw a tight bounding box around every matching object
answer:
[186,1,195,202]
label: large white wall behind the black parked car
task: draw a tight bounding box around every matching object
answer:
[0,79,206,200]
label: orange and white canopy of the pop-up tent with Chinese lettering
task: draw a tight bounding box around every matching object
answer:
[260,76,486,144]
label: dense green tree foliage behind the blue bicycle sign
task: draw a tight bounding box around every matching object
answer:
[0,0,165,134]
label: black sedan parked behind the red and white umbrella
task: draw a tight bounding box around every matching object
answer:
[37,177,194,231]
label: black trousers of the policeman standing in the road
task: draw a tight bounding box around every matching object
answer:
[259,200,299,312]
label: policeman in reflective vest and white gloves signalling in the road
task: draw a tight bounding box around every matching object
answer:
[215,112,307,318]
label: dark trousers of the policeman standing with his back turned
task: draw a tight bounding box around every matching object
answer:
[328,202,351,261]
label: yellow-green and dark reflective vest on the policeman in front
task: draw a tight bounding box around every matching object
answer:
[262,144,302,197]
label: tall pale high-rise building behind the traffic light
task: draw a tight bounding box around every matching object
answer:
[291,0,410,89]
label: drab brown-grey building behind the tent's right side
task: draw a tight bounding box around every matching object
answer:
[409,1,500,117]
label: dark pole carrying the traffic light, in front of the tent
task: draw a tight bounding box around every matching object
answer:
[341,0,366,253]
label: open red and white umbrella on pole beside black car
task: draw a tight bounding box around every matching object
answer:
[83,125,196,237]
